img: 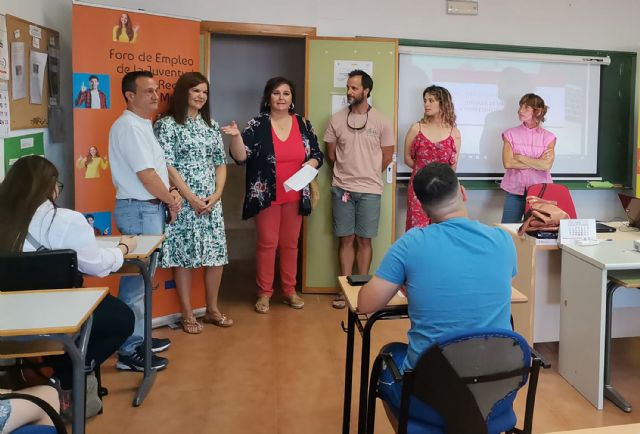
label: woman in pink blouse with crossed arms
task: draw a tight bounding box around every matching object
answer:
[500,93,556,223]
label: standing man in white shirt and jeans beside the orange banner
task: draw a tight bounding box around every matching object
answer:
[109,71,182,371]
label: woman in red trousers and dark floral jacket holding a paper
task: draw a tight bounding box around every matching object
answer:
[222,77,323,313]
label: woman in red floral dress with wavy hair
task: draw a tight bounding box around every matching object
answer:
[404,86,461,231]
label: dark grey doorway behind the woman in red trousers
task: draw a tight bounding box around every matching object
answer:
[209,33,305,261]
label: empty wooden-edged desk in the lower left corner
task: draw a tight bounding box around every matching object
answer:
[0,288,108,434]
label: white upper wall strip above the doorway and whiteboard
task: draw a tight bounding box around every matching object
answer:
[80,0,640,51]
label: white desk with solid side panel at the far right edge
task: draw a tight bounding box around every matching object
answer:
[558,241,640,411]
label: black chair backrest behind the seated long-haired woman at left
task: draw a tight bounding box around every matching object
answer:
[0,249,82,291]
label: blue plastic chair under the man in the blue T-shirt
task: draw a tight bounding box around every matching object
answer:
[366,329,550,434]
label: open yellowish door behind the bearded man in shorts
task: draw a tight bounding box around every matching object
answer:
[302,37,398,293]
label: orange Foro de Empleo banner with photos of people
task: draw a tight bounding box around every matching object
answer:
[72,4,204,317]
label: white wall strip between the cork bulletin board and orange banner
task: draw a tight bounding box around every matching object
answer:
[0,0,74,207]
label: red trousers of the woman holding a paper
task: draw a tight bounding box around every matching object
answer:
[256,201,302,297]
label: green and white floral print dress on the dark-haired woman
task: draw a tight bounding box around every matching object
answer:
[154,114,229,268]
